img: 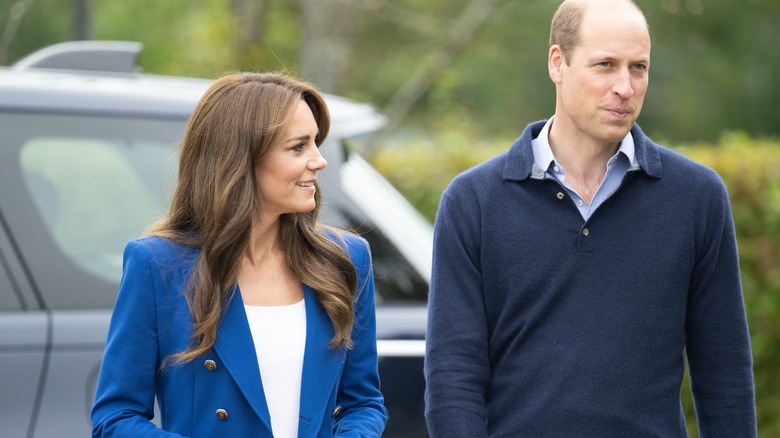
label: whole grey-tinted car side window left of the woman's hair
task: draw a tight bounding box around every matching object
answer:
[0,113,185,309]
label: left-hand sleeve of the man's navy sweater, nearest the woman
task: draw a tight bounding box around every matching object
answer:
[425,179,490,438]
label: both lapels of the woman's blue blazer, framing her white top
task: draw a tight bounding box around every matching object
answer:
[214,285,346,437]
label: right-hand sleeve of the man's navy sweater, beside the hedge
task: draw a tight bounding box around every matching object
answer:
[686,179,757,438]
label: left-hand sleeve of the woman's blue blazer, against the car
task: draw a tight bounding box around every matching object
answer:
[92,241,181,437]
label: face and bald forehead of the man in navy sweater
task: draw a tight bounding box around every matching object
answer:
[550,2,650,144]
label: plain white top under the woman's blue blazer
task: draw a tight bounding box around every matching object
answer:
[244,300,306,438]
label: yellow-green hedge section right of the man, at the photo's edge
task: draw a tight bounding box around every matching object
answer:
[680,133,780,437]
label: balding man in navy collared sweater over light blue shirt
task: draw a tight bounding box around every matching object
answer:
[425,0,757,438]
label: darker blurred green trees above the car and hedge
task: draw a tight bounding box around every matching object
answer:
[0,0,780,142]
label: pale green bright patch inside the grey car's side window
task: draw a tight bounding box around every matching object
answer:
[20,135,174,281]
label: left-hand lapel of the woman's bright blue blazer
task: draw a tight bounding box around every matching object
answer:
[214,287,271,435]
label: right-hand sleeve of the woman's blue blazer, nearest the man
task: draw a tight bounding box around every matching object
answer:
[334,238,387,437]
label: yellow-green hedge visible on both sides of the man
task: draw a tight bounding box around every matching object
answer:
[369,133,780,437]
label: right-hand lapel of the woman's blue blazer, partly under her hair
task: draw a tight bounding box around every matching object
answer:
[298,285,346,437]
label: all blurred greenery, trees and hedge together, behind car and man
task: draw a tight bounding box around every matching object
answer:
[0,0,780,437]
